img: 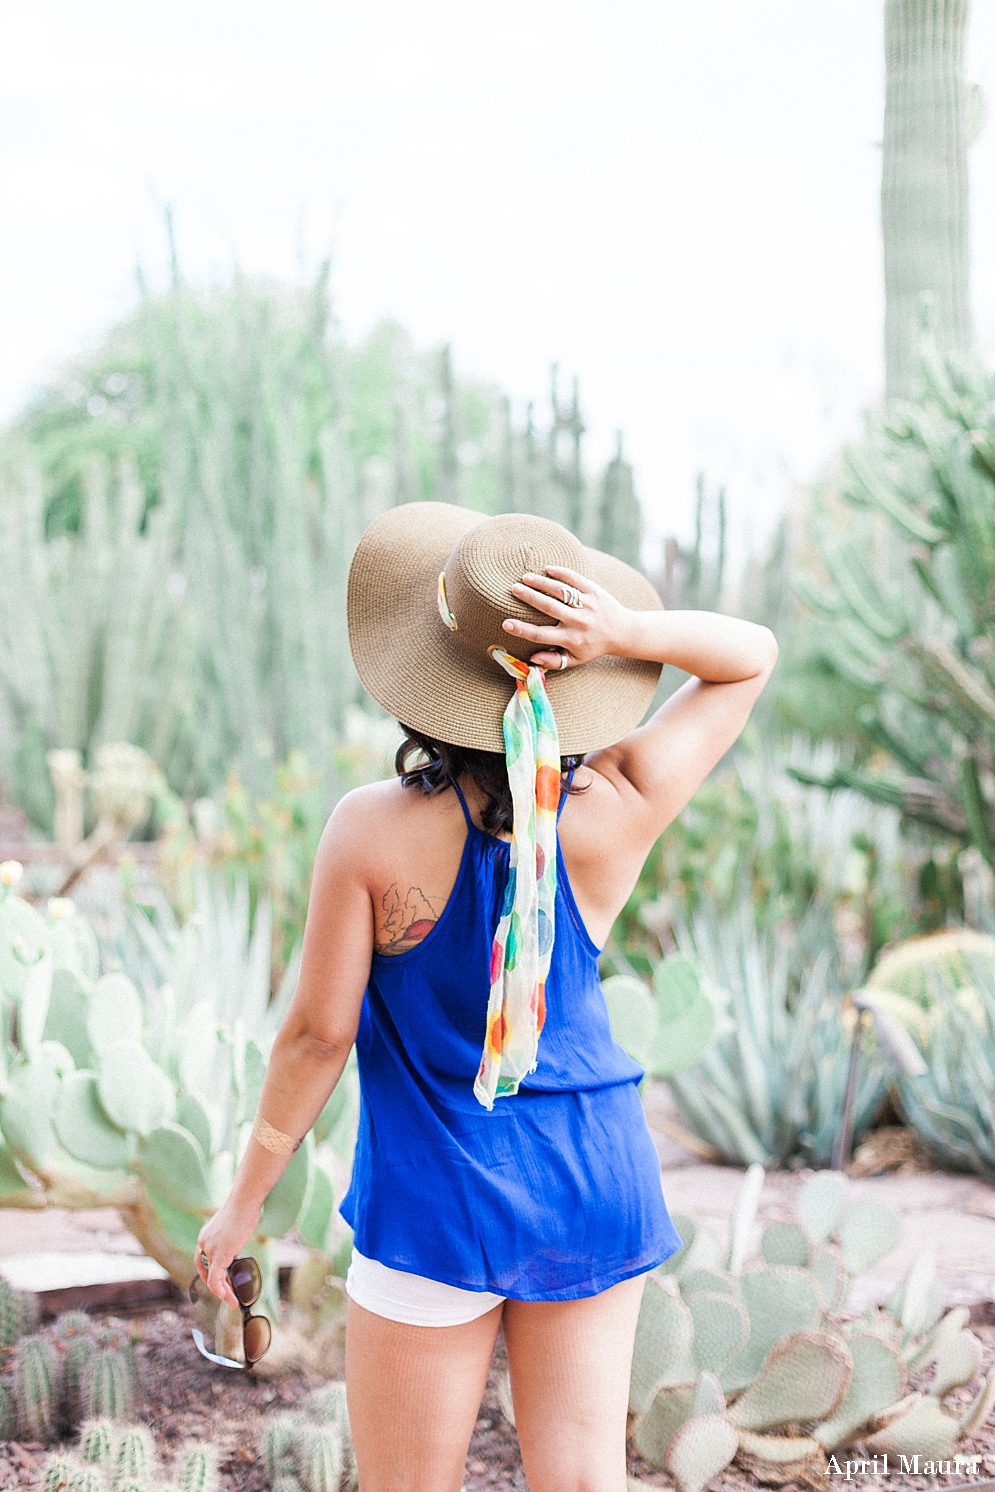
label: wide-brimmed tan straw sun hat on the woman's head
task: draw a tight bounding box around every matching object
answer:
[348,503,661,756]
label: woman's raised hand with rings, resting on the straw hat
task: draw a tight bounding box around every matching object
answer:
[503,565,633,673]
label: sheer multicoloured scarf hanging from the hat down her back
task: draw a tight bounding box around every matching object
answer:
[473,648,559,1109]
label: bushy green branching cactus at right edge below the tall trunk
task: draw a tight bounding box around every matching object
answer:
[795,364,995,865]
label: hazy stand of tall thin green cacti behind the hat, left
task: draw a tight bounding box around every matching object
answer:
[0,272,638,828]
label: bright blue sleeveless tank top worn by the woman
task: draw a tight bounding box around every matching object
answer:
[340,783,680,1301]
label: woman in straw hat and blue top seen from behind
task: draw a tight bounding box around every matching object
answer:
[198,503,777,1492]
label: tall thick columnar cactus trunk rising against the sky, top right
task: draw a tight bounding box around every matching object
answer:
[882,0,980,397]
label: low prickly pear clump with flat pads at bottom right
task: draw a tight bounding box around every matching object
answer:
[630,1167,995,1492]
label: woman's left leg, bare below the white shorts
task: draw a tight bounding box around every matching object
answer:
[346,1300,507,1492]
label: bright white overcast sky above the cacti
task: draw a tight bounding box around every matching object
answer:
[0,0,995,560]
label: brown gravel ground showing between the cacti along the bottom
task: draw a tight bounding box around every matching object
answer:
[0,1308,995,1492]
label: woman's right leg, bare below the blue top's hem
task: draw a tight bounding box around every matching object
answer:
[504,1276,644,1492]
